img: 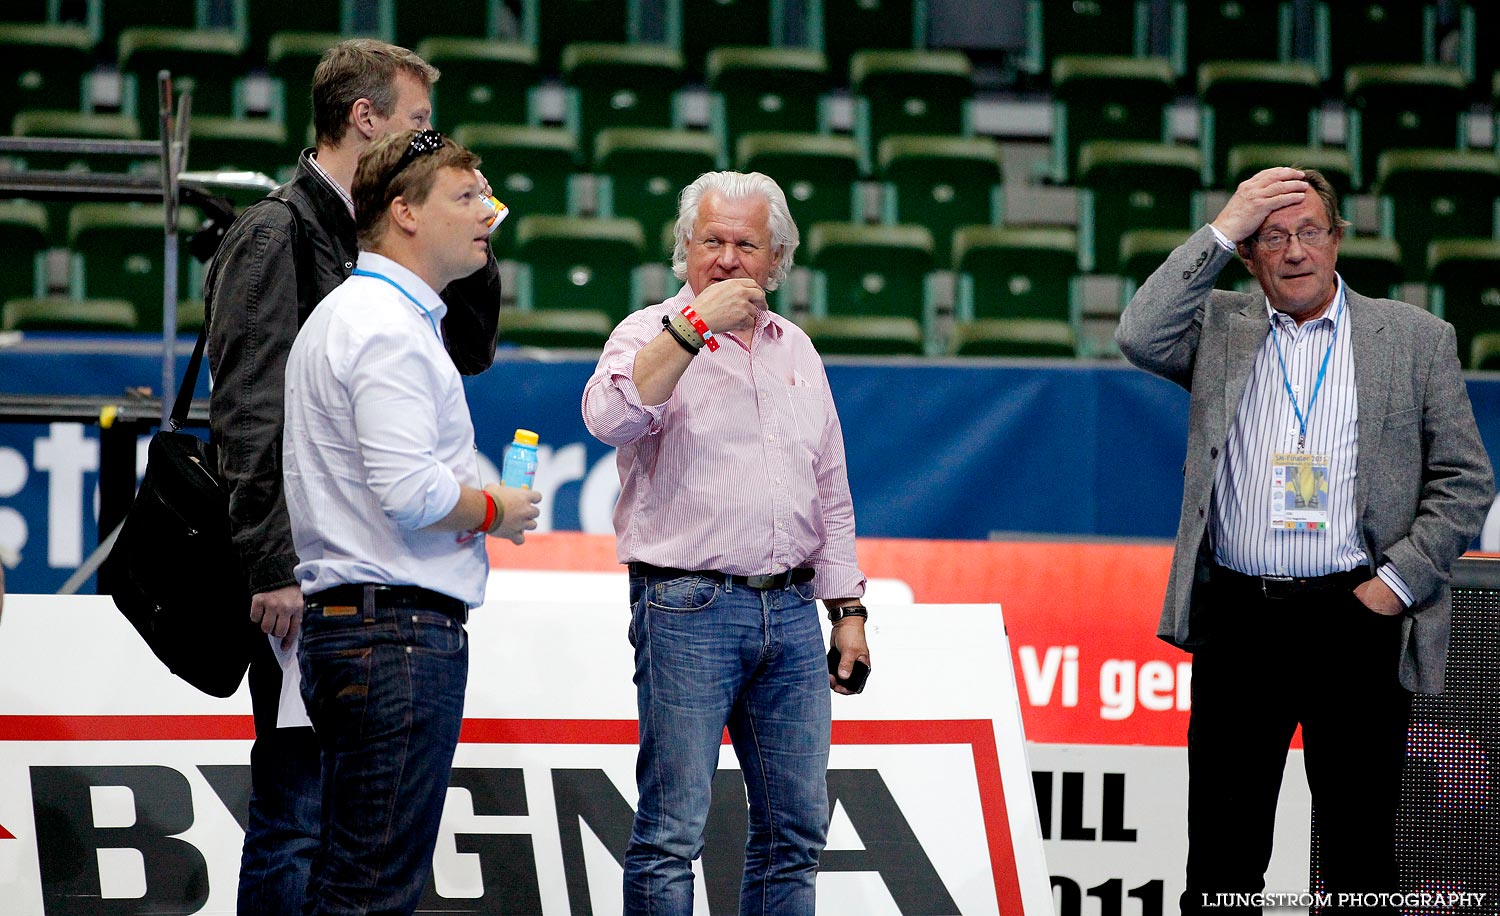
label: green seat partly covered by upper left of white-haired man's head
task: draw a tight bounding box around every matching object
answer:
[594,127,719,236]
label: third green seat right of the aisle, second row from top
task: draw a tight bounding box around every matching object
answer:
[1344,64,1469,190]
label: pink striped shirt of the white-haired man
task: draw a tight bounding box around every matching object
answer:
[584,286,864,598]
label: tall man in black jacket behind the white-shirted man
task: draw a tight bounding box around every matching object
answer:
[204,39,500,916]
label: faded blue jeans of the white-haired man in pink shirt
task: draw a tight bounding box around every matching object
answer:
[624,576,831,916]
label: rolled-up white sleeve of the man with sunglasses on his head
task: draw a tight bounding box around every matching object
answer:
[336,324,459,531]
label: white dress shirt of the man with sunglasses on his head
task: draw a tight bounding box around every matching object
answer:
[282,252,489,607]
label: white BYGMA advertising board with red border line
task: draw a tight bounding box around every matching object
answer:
[0,593,1052,916]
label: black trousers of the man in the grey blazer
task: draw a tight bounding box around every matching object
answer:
[1181,588,1412,916]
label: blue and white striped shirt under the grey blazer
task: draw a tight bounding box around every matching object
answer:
[1209,277,1412,606]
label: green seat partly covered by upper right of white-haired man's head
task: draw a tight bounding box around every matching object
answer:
[735,133,861,226]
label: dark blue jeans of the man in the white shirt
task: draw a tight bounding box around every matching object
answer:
[299,606,468,916]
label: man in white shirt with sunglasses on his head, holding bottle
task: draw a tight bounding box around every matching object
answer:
[284,130,540,916]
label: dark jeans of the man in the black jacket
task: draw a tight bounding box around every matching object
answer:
[237,634,323,916]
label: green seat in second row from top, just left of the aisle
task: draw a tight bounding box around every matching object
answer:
[849,51,974,168]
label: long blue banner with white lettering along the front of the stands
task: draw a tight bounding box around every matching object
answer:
[0,351,1500,592]
